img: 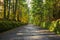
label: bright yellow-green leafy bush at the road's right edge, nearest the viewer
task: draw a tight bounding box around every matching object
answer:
[49,20,60,34]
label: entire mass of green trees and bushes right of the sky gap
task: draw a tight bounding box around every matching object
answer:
[31,0,60,33]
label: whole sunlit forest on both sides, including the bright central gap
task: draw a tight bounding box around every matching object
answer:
[0,0,60,32]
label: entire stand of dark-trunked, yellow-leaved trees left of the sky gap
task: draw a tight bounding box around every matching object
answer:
[0,0,28,23]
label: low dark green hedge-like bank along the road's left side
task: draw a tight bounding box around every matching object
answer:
[0,21,23,32]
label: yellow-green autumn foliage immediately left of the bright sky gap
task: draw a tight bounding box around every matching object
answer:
[18,0,29,23]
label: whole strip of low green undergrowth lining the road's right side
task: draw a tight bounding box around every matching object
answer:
[40,19,60,34]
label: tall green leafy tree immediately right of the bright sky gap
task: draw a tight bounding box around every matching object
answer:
[31,0,43,25]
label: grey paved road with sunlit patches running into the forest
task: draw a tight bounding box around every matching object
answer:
[0,24,60,40]
